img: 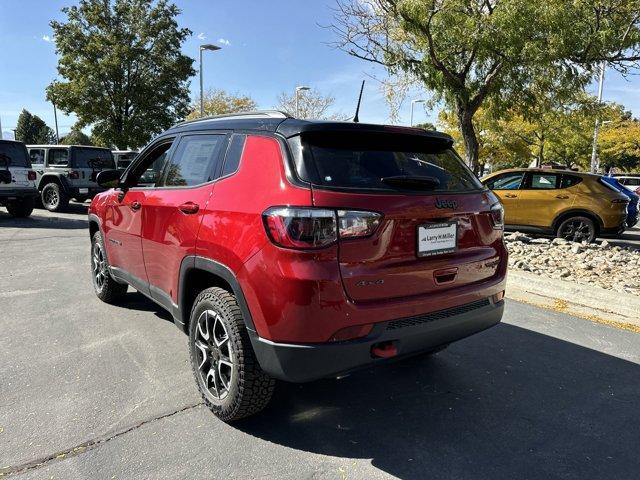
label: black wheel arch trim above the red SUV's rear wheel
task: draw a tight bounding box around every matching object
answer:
[175,255,256,333]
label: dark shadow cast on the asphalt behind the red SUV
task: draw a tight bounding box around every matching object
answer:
[234,324,640,479]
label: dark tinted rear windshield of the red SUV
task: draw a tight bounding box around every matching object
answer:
[302,132,483,192]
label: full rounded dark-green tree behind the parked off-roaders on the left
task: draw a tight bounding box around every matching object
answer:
[47,0,195,148]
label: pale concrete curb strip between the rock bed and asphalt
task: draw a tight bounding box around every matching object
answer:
[506,270,640,333]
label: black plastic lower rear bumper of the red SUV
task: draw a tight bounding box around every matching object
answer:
[251,298,504,383]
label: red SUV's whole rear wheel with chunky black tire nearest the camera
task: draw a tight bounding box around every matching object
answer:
[189,287,276,422]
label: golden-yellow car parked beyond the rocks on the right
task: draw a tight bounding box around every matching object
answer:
[482,168,629,242]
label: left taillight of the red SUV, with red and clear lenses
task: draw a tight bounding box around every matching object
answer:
[262,207,382,249]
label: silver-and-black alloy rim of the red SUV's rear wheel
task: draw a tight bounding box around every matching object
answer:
[194,310,234,400]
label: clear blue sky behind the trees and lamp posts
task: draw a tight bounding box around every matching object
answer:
[0,0,640,138]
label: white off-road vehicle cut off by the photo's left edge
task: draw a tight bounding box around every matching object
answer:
[0,140,38,217]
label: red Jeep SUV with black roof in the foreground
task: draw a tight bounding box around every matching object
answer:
[89,112,507,421]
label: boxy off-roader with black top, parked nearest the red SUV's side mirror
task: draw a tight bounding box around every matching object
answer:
[27,145,115,212]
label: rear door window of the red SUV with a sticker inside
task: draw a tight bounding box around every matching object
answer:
[164,135,225,187]
